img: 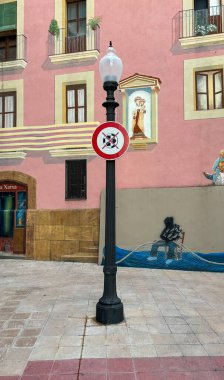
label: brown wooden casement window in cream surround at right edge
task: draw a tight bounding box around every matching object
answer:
[195,70,224,111]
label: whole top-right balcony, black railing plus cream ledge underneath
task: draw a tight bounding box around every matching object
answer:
[178,6,224,48]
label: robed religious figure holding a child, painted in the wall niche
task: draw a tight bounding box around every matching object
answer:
[131,96,146,139]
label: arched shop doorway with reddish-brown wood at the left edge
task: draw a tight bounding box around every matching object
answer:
[0,182,27,254]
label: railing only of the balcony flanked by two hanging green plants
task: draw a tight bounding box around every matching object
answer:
[49,26,100,56]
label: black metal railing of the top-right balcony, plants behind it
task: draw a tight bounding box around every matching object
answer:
[178,6,224,38]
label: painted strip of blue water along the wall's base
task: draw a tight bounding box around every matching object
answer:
[110,247,224,272]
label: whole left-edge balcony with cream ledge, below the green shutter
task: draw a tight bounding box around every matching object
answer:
[0,35,27,71]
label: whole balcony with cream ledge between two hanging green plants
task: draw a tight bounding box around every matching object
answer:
[49,26,100,64]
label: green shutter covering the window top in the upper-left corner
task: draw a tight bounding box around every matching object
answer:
[0,1,17,32]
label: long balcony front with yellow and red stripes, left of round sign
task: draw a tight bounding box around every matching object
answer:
[0,122,98,159]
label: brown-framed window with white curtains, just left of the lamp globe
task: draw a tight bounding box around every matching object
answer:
[66,84,86,123]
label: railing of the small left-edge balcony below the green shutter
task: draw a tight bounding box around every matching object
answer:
[0,34,27,62]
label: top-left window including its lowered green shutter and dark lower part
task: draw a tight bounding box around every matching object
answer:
[0,2,17,61]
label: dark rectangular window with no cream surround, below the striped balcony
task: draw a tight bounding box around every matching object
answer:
[65,160,87,199]
